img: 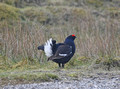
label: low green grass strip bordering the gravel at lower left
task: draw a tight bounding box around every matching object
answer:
[0,72,59,85]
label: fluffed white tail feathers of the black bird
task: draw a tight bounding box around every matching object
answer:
[44,38,53,57]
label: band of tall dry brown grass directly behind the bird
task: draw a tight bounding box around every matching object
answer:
[1,17,120,58]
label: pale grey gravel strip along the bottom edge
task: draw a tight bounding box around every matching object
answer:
[4,78,120,89]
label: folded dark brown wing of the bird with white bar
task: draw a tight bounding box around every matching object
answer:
[50,44,72,60]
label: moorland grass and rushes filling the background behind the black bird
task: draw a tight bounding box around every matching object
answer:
[0,0,120,84]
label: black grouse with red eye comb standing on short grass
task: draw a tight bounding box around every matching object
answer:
[38,34,76,68]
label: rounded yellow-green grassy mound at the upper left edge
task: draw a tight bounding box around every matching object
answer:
[0,3,22,30]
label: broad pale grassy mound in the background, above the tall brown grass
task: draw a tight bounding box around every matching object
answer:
[21,6,87,25]
